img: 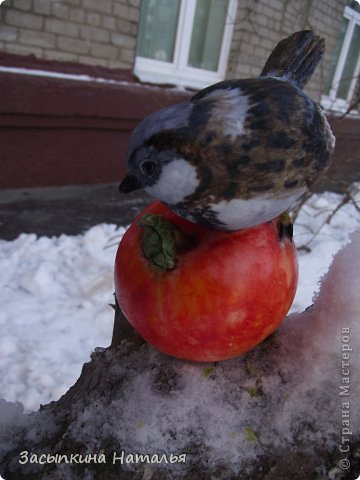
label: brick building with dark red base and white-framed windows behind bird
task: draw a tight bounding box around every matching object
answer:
[0,0,360,188]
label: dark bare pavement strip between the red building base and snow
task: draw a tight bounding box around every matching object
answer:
[0,163,360,240]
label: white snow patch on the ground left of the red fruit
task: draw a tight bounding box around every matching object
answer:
[0,225,125,410]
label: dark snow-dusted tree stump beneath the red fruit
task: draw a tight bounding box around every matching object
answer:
[0,232,360,480]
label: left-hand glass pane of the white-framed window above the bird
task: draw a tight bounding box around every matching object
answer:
[137,0,180,62]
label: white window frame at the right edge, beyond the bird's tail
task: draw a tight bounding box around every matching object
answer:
[321,6,360,115]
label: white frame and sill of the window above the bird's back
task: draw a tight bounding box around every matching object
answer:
[134,0,238,89]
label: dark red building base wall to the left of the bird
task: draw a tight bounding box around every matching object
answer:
[0,64,189,189]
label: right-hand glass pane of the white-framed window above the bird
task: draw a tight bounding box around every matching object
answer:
[188,0,229,71]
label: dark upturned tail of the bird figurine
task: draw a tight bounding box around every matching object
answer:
[261,30,325,88]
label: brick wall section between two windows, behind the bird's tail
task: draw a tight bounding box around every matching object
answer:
[227,0,347,102]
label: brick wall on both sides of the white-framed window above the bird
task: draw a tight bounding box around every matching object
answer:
[0,0,347,97]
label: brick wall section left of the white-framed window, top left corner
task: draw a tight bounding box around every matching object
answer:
[0,0,140,69]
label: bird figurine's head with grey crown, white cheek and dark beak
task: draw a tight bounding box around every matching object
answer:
[120,103,199,204]
